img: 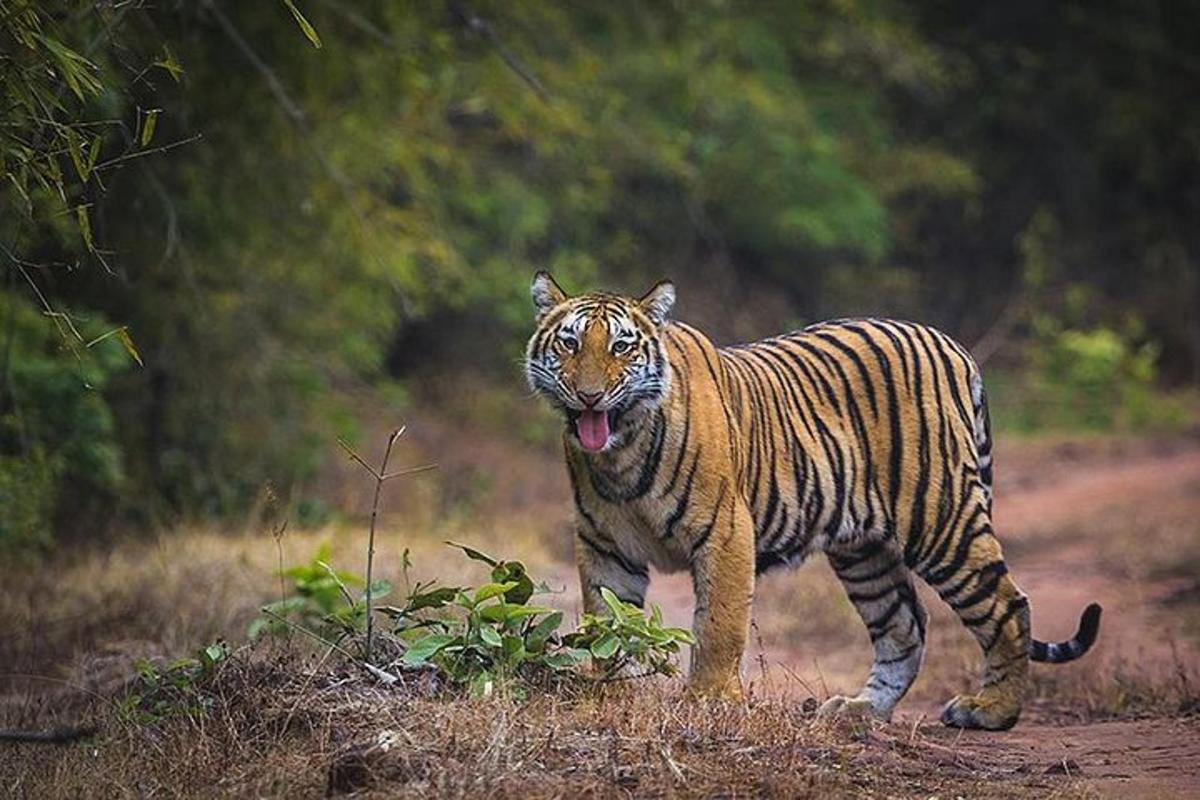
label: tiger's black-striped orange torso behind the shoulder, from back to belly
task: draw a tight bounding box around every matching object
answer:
[720,319,991,572]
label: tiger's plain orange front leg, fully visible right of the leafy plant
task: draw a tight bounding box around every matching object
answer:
[689,498,755,702]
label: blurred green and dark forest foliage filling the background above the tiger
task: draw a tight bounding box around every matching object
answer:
[0,0,1200,539]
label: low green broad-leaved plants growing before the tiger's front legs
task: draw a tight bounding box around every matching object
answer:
[258,542,692,697]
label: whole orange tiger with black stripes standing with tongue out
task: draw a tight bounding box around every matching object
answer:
[524,271,1100,729]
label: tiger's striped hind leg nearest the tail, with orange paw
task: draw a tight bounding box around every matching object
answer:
[918,525,1030,730]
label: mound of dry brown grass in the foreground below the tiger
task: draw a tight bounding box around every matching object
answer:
[0,644,1086,798]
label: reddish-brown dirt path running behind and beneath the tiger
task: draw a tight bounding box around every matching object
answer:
[628,445,1200,800]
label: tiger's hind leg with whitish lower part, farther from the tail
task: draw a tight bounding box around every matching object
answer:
[818,541,926,720]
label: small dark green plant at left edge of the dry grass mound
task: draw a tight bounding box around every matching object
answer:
[120,639,229,724]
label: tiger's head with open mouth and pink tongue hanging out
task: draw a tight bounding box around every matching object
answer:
[526,272,674,452]
